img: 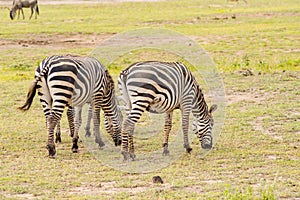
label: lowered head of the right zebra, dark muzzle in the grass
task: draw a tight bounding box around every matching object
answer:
[192,105,217,149]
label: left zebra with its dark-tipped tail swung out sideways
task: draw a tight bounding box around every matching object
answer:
[19,55,122,156]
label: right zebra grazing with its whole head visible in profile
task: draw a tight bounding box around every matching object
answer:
[118,61,217,160]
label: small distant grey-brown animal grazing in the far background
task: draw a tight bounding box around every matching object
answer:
[9,0,40,20]
